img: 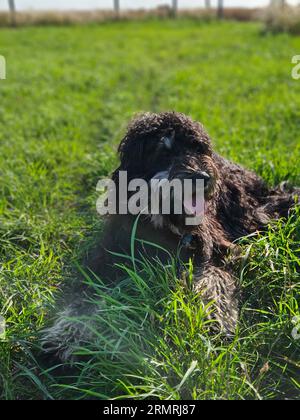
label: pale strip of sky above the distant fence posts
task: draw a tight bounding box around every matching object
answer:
[0,0,299,10]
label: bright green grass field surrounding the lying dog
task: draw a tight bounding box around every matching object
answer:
[0,20,300,399]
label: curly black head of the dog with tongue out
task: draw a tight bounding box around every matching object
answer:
[113,112,218,231]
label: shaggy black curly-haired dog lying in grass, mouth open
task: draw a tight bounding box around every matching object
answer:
[43,112,299,360]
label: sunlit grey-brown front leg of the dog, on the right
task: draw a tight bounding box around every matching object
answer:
[194,265,238,335]
